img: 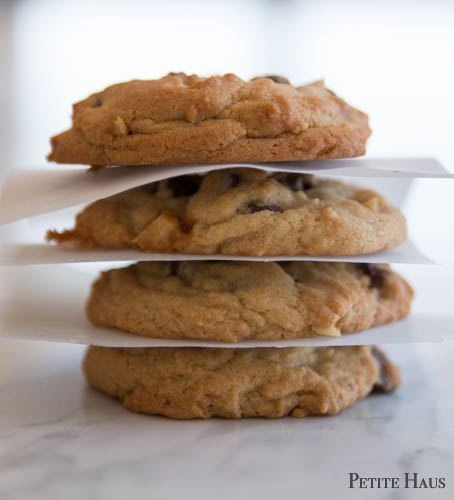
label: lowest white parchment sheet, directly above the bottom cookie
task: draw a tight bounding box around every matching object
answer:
[0,266,454,347]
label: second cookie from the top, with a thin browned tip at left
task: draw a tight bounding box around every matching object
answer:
[47,168,406,256]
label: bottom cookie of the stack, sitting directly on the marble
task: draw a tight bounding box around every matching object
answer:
[84,346,400,419]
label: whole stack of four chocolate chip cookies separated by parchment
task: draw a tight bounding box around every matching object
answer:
[47,73,413,418]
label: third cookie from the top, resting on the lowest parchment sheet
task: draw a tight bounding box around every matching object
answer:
[86,261,413,342]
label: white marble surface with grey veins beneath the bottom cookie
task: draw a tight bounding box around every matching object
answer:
[0,340,454,500]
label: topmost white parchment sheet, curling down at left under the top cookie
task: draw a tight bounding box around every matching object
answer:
[0,158,448,224]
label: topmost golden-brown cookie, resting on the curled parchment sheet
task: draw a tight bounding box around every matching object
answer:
[48,73,370,166]
